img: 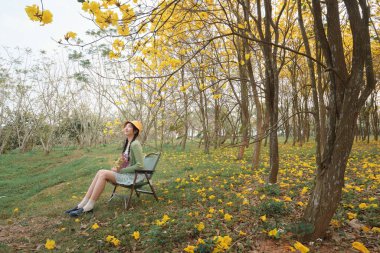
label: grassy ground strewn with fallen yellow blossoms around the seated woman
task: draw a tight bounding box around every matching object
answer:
[0,139,380,252]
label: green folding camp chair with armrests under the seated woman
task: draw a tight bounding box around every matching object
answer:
[108,153,161,210]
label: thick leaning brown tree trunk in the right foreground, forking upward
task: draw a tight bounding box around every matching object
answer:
[303,0,376,240]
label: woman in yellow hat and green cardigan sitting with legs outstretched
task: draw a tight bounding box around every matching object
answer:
[65,121,144,217]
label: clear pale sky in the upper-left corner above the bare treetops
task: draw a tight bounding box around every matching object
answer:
[0,0,95,51]
